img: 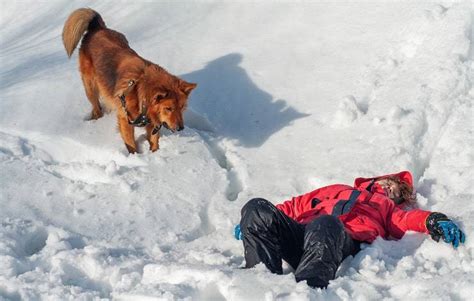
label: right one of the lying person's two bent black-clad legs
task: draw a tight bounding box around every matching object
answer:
[295,215,360,288]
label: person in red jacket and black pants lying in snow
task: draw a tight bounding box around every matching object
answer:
[234,171,465,288]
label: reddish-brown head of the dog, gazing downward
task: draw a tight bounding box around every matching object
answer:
[137,64,196,132]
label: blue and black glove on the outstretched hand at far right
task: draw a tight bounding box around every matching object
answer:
[426,212,466,248]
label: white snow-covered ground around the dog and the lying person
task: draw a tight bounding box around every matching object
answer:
[0,1,474,300]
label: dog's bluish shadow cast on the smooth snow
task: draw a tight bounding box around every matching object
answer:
[181,53,309,148]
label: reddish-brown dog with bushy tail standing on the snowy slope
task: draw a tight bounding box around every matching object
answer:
[63,8,196,153]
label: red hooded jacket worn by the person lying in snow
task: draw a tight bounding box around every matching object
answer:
[276,171,431,242]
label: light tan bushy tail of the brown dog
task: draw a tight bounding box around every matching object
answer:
[63,8,105,57]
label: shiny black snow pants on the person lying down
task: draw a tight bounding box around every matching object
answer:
[240,198,360,288]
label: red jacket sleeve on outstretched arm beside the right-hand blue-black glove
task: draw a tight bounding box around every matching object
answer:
[386,200,431,239]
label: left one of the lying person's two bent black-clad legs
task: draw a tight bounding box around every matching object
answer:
[240,198,304,274]
